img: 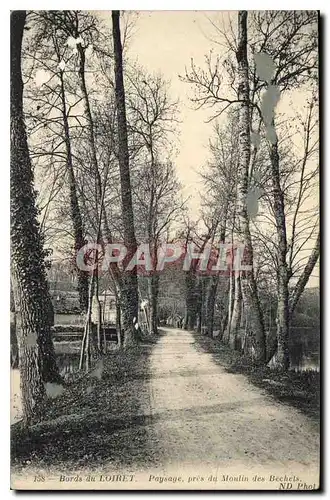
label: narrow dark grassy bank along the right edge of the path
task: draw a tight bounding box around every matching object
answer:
[194,333,320,422]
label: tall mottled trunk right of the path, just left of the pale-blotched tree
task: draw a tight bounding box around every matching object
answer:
[236,11,266,363]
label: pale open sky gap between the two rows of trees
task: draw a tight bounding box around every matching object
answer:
[125,11,221,210]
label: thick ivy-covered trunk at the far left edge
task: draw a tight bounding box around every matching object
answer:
[10,11,60,423]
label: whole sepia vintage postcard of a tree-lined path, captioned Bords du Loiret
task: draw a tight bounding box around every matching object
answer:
[10,10,321,491]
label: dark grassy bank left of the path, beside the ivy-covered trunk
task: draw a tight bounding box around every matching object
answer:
[11,342,159,473]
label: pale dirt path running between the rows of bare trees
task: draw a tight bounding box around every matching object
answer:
[142,329,319,487]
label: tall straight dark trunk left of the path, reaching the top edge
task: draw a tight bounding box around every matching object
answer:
[112,11,138,347]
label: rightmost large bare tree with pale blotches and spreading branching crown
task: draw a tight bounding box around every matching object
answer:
[253,12,317,369]
